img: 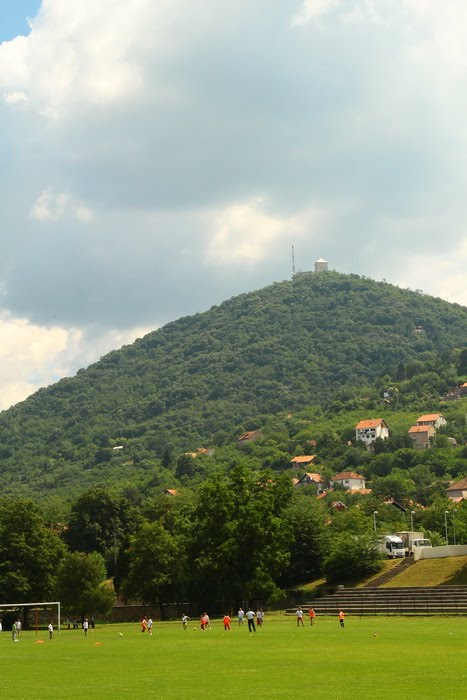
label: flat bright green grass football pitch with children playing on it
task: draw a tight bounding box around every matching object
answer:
[0,615,467,700]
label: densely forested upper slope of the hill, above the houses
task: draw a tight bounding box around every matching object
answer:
[0,272,467,504]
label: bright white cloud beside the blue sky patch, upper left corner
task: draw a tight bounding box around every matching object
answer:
[0,0,150,118]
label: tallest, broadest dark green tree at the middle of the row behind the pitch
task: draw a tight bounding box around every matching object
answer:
[189,466,291,603]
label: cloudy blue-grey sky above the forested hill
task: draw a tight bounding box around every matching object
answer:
[0,0,467,409]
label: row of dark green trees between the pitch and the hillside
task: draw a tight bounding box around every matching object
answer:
[5,465,467,616]
